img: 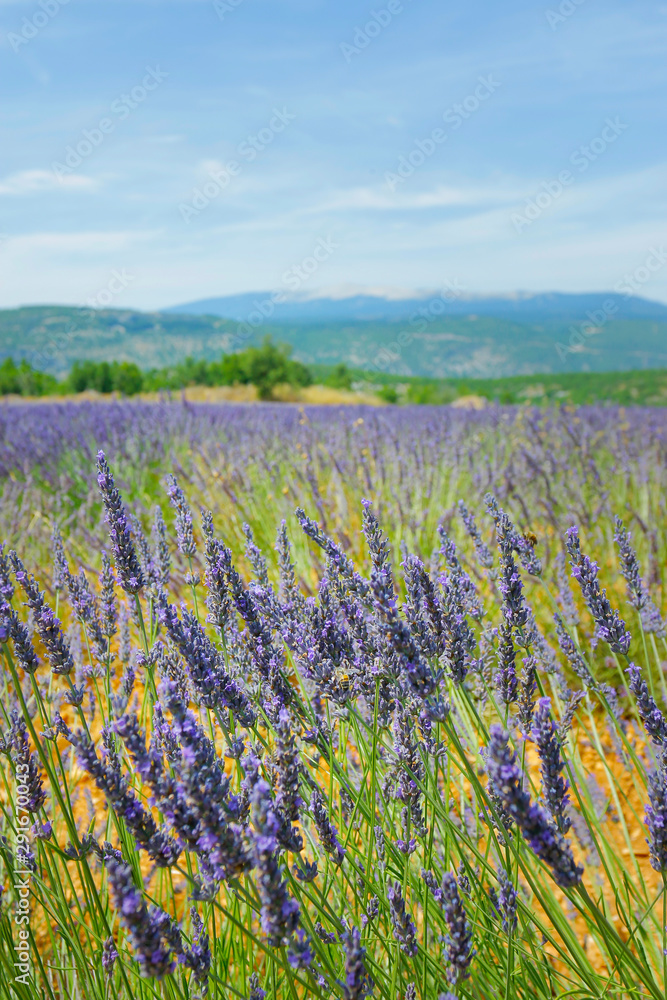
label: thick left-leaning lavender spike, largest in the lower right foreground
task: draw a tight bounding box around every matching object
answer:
[486,725,583,888]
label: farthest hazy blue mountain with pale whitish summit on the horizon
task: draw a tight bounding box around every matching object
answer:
[164,291,667,323]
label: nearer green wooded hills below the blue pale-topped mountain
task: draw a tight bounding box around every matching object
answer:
[0,295,667,378]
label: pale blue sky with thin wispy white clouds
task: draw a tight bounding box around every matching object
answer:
[0,0,667,310]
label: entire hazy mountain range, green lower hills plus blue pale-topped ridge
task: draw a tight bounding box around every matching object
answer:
[0,292,667,378]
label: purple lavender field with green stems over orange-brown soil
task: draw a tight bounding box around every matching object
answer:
[0,402,667,1000]
